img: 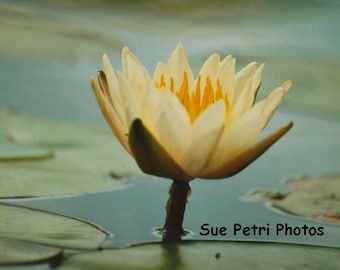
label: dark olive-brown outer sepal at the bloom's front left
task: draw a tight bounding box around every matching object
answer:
[129,119,193,181]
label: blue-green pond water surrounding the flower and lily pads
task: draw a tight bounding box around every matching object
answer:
[0,0,340,247]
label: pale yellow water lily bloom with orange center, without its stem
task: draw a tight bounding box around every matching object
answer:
[91,44,292,182]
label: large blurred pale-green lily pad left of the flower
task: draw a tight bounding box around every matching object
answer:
[0,112,143,197]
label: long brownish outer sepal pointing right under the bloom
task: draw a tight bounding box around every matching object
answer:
[198,122,293,179]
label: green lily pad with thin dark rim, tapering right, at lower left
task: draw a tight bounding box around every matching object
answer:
[0,203,109,249]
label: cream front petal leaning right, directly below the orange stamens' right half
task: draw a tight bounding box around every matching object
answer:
[180,101,225,175]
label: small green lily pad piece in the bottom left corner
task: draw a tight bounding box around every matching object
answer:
[0,238,62,267]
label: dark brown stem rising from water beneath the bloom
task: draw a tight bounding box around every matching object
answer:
[162,180,190,242]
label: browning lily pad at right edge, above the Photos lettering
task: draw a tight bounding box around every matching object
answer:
[246,175,340,224]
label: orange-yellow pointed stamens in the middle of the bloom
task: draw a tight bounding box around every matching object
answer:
[156,72,230,123]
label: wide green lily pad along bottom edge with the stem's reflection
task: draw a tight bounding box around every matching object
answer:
[58,241,340,270]
